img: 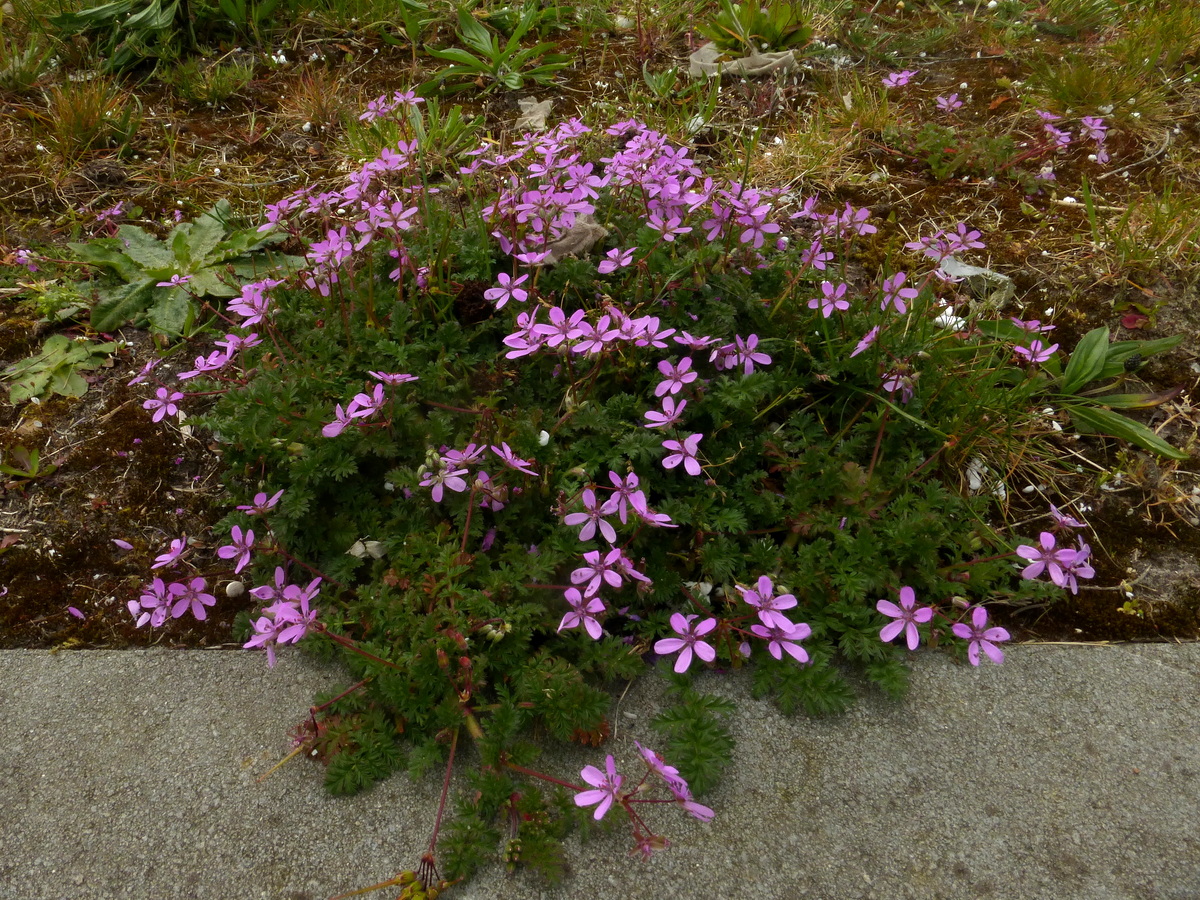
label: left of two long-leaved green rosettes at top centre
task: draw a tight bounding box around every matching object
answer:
[420,5,571,94]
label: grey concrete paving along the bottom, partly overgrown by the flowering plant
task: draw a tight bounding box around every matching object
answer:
[0,644,1200,900]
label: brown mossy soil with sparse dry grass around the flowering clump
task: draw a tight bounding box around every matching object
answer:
[0,13,1200,648]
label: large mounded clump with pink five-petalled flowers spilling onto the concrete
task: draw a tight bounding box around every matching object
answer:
[110,94,1180,895]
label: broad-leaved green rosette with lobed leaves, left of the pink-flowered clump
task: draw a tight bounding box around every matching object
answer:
[67,200,300,335]
